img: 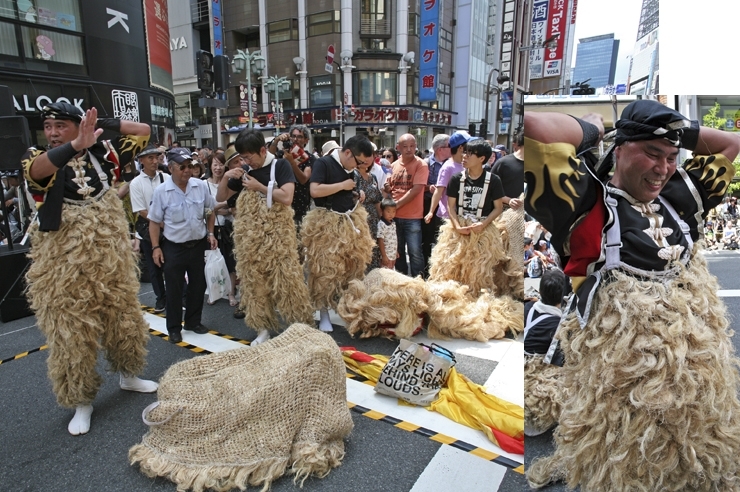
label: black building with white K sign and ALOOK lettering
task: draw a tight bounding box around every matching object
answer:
[0,0,175,145]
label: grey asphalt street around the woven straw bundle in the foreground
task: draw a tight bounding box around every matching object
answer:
[0,274,526,492]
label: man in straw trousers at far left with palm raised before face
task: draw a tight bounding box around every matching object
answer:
[23,102,157,435]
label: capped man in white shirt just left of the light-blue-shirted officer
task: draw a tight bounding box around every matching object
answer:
[129,144,170,313]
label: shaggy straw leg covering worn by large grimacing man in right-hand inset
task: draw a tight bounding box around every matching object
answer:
[527,254,740,492]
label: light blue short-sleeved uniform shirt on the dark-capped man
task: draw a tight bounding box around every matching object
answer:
[149,178,216,243]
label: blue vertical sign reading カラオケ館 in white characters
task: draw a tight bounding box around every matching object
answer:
[419,0,439,102]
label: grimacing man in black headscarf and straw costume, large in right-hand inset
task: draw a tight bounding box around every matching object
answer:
[524,100,740,491]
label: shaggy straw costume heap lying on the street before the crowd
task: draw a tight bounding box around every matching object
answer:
[337,268,524,341]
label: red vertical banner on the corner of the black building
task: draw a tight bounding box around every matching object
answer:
[144,0,173,94]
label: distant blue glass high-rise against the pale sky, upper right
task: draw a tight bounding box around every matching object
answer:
[573,33,619,92]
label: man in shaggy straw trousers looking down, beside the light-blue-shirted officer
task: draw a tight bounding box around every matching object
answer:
[216,130,313,345]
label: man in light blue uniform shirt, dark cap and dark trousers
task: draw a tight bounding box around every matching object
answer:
[149,147,218,343]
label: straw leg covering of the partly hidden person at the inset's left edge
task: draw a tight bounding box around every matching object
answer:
[524,355,562,435]
